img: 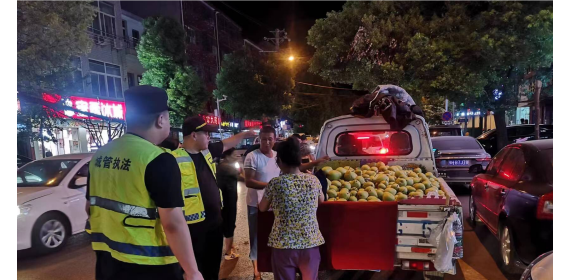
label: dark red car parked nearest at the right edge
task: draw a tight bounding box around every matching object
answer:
[469,140,554,272]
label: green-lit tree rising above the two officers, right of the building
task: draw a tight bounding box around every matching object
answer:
[137,16,208,126]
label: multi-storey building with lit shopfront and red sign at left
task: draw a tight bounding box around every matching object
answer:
[27,1,144,159]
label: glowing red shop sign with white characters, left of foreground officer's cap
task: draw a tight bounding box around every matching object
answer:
[42,93,126,120]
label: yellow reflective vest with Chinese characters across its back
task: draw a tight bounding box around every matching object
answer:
[87,134,178,265]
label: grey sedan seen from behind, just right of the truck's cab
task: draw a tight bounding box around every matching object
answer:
[431,136,491,186]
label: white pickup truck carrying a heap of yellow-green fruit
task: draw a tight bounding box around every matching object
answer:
[315,115,463,279]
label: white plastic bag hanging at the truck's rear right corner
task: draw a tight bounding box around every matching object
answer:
[428,213,459,272]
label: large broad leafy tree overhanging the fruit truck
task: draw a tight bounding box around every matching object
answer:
[308,2,552,150]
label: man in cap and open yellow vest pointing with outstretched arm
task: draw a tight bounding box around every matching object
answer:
[172,117,255,280]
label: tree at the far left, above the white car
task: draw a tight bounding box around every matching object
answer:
[17,1,95,153]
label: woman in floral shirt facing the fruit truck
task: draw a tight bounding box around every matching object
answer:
[259,138,325,280]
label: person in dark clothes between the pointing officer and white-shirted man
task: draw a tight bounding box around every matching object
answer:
[216,148,240,260]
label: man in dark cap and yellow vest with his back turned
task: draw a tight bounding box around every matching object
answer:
[86,86,203,280]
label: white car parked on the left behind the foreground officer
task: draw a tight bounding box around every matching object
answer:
[17,154,93,253]
